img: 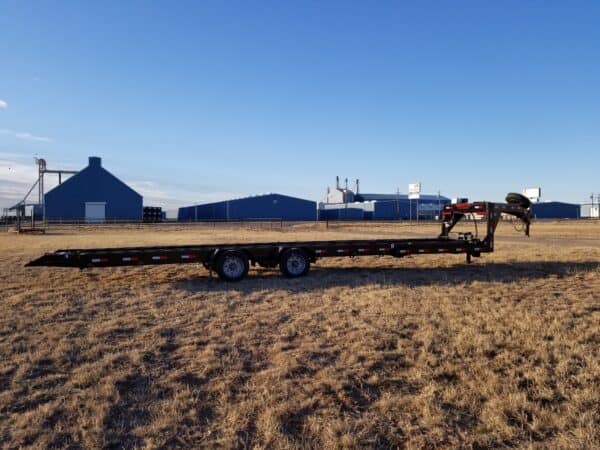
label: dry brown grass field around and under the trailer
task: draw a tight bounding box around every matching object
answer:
[0,222,600,449]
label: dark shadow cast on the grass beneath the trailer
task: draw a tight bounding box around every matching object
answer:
[175,261,600,293]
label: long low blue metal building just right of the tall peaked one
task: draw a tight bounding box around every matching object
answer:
[177,194,317,222]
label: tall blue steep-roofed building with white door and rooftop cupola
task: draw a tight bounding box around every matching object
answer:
[44,156,143,222]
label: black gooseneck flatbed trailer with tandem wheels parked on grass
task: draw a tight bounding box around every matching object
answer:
[26,194,531,281]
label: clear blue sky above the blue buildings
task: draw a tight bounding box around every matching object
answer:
[0,0,600,209]
